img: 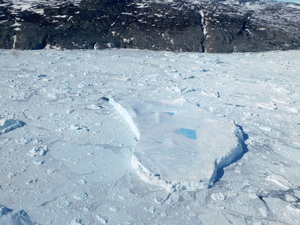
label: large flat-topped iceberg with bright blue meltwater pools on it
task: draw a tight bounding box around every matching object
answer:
[109,98,245,191]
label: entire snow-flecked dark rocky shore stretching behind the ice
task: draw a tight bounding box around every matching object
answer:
[0,0,300,53]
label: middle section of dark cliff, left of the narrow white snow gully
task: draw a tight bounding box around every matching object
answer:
[45,0,204,51]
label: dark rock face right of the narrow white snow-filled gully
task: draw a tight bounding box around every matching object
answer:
[202,2,300,53]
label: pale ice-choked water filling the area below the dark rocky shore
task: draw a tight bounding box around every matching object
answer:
[0,50,300,225]
